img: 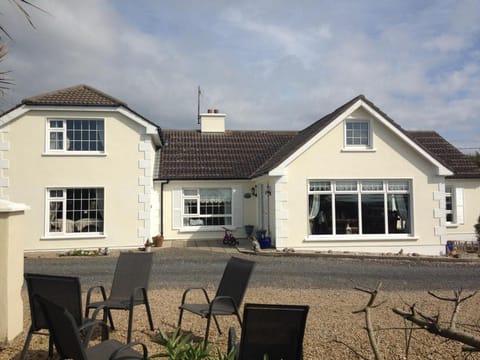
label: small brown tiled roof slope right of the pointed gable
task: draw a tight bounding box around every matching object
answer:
[408,131,480,179]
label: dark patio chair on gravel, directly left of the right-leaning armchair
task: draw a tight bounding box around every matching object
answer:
[85,252,154,342]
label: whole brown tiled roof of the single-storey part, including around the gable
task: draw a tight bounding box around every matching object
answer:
[158,95,480,180]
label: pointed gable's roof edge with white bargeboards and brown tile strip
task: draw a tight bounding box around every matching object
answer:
[262,95,453,176]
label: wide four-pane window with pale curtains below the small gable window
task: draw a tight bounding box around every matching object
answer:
[308,180,412,235]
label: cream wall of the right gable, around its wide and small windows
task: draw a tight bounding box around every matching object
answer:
[275,111,445,255]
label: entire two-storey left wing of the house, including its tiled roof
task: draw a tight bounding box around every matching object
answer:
[0,85,160,251]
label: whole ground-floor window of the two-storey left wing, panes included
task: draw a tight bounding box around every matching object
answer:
[47,188,104,235]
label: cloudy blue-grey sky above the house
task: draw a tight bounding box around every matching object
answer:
[0,0,480,152]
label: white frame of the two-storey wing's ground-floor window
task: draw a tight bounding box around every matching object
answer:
[45,186,105,238]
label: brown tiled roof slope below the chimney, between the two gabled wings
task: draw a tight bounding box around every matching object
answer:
[158,130,297,180]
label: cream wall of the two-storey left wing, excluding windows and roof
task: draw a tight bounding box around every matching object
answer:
[0,111,154,251]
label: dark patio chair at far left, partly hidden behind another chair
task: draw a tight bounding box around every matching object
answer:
[20,273,104,360]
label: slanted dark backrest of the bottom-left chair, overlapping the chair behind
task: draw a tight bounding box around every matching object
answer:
[34,295,87,360]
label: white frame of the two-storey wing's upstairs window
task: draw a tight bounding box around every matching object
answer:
[45,118,106,155]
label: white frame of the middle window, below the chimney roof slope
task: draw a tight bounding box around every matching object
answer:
[181,187,235,230]
